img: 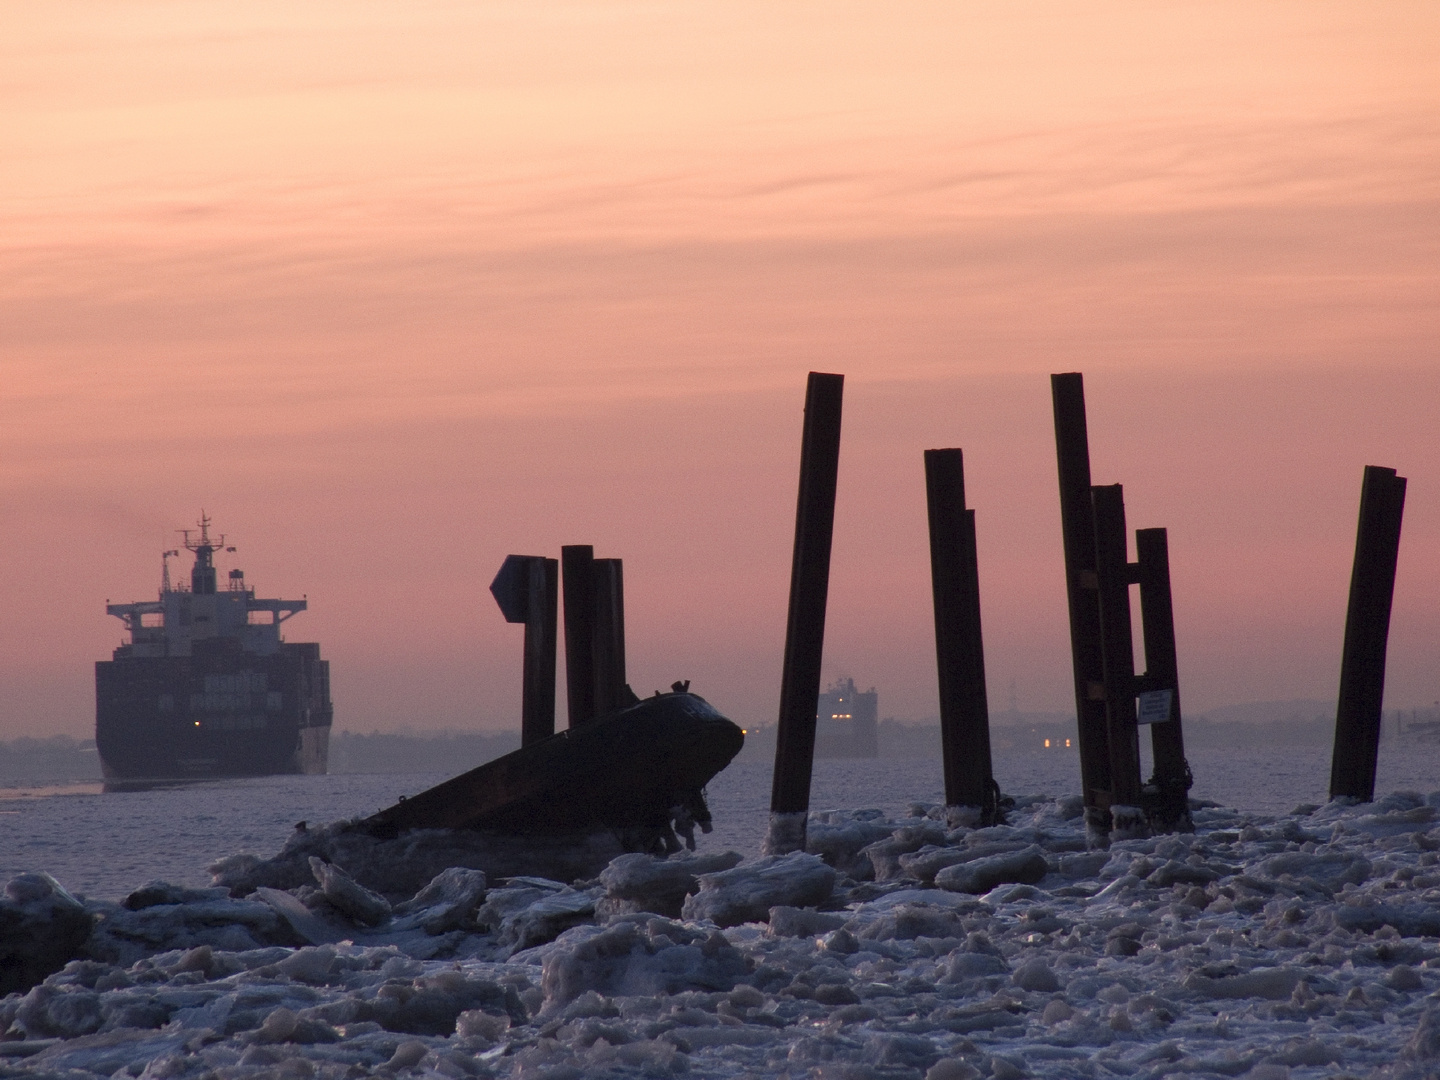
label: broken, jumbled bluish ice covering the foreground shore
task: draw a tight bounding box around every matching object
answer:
[8,792,1440,1080]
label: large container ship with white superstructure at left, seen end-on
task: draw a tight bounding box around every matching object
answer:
[95,514,334,788]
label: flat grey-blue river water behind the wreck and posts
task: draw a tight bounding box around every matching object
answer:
[0,742,1440,900]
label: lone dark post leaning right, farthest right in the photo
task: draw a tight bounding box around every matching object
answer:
[1331,465,1405,802]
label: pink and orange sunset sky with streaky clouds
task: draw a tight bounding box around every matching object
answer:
[0,0,1440,739]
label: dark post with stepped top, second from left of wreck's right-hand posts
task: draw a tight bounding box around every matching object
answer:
[924,448,999,825]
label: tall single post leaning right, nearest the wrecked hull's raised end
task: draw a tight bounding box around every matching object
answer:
[765,372,845,855]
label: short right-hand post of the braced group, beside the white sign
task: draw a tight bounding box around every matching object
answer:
[1135,528,1194,829]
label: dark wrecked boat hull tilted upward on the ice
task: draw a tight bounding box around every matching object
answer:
[363,691,744,850]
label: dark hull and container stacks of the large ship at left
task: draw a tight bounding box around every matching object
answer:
[95,639,333,788]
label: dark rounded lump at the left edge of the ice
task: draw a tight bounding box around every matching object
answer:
[0,873,92,996]
